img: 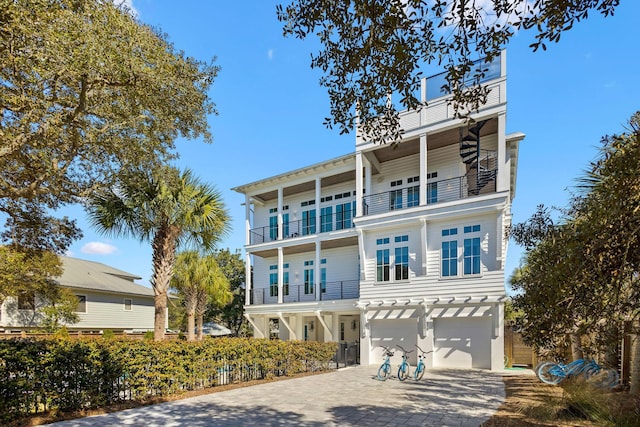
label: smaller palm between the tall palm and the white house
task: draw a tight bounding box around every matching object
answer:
[171,251,232,341]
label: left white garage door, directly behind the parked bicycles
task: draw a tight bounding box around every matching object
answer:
[369,319,418,366]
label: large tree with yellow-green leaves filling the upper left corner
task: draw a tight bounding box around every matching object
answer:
[0,0,218,251]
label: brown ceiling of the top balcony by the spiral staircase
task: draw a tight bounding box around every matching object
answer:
[373,119,498,163]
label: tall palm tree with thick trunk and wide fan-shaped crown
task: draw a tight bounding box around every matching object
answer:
[88,166,229,341]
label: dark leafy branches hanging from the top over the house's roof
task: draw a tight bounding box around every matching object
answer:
[277,0,620,141]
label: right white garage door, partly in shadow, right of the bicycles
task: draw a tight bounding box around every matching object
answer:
[433,317,492,369]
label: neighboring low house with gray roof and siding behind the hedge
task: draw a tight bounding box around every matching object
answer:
[0,257,154,333]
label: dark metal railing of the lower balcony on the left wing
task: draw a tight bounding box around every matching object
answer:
[250,280,360,305]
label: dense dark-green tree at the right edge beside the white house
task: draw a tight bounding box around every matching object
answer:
[512,112,640,386]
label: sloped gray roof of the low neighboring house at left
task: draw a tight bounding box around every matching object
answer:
[57,257,154,297]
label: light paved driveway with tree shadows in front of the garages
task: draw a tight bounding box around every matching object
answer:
[47,367,505,427]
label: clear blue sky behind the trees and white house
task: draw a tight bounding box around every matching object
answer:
[64,0,640,285]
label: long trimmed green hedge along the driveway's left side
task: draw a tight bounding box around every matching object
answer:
[0,338,336,424]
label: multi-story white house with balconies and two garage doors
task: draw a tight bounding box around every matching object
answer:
[234,53,524,370]
